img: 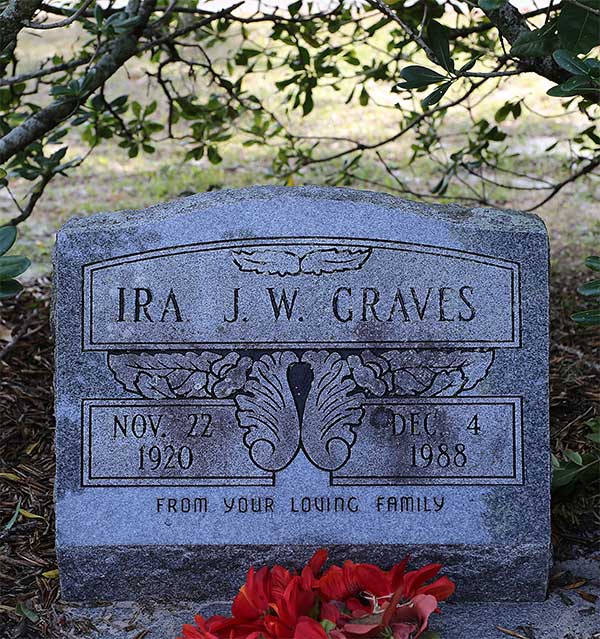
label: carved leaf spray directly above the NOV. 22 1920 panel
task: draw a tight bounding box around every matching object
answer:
[108,351,252,399]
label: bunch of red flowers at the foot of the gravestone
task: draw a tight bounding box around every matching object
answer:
[179,550,454,639]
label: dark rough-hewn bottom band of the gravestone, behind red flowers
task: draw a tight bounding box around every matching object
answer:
[58,544,550,601]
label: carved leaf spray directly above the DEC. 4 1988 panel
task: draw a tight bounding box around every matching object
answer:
[368,349,494,397]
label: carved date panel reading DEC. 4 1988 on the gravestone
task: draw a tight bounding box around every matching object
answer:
[332,397,523,486]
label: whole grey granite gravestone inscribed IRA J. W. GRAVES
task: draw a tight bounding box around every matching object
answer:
[54,187,550,601]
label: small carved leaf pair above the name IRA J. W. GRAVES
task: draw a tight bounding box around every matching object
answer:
[233,248,371,275]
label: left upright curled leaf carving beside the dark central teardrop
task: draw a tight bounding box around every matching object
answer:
[236,352,300,471]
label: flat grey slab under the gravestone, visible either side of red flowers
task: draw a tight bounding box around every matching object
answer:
[52,556,600,639]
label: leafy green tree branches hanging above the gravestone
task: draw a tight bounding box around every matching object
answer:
[0,0,600,229]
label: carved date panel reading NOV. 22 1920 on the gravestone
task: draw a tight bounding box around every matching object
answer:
[82,399,273,486]
